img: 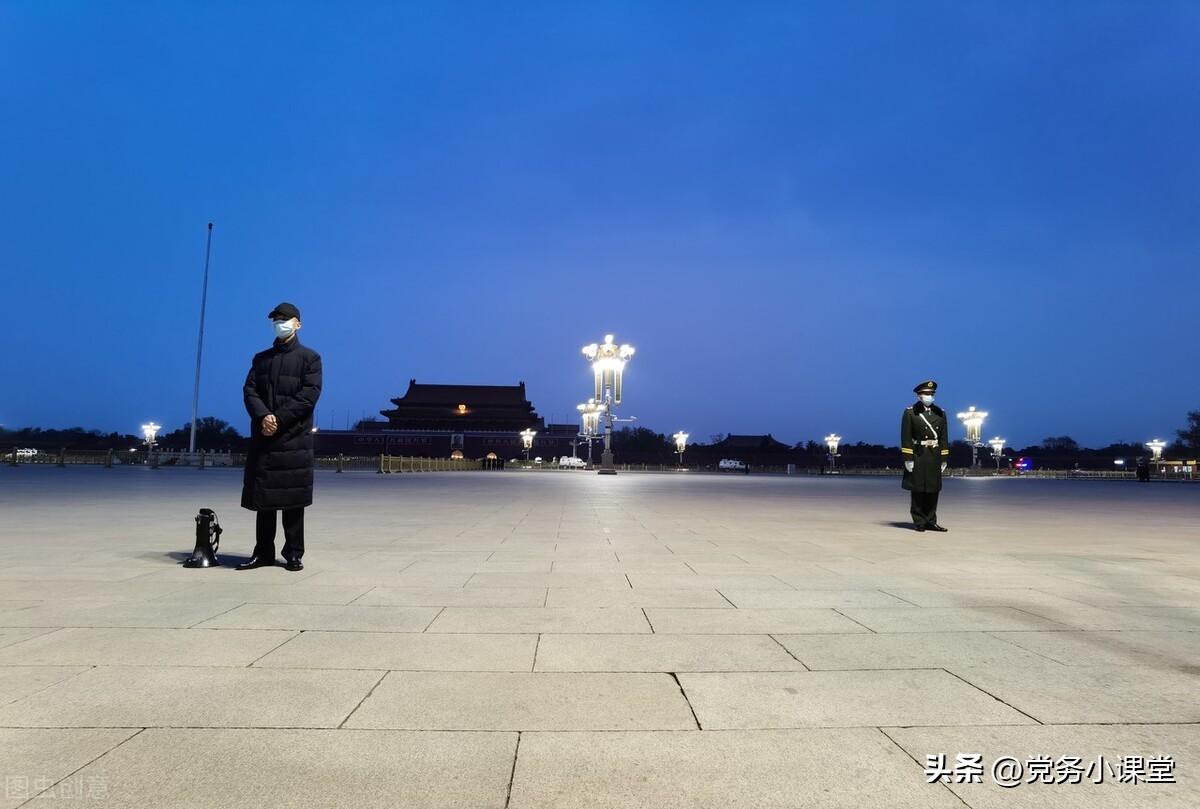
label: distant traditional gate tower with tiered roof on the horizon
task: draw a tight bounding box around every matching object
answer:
[316,379,578,460]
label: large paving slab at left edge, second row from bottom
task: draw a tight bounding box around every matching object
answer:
[0,666,379,727]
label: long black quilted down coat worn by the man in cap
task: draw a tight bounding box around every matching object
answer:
[241,337,320,511]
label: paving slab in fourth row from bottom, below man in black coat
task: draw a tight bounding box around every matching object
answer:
[198,604,438,633]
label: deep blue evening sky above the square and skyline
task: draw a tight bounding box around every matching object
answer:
[0,0,1200,444]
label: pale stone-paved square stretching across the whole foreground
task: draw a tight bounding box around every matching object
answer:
[0,467,1200,809]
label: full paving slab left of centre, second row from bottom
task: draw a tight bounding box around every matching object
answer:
[346,672,696,731]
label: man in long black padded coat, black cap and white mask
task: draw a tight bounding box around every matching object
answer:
[238,298,320,570]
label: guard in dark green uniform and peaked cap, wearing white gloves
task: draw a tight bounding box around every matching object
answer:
[900,379,950,531]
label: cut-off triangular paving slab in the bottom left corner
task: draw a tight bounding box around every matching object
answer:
[0,727,138,809]
